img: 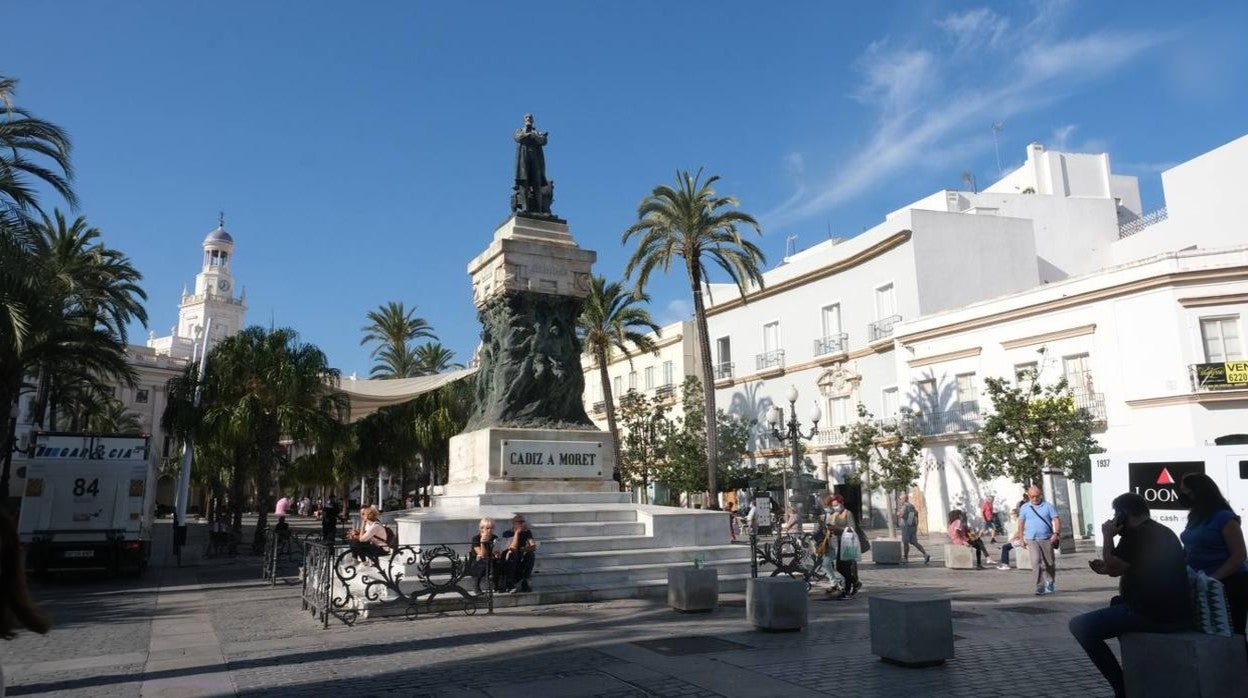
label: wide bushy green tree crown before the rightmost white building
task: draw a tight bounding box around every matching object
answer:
[957,370,1101,484]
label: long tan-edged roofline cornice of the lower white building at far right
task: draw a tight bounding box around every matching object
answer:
[897,265,1248,343]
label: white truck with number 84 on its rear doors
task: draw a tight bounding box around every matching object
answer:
[17,433,155,574]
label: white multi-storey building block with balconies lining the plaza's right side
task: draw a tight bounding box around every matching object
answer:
[708,137,1248,529]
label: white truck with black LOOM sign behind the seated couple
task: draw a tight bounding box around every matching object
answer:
[1092,445,1248,546]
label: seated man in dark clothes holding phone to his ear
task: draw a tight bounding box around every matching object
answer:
[1070,493,1192,697]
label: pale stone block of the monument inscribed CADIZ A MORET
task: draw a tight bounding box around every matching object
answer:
[444,427,619,498]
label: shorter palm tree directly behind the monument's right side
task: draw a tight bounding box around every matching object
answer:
[577,276,660,492]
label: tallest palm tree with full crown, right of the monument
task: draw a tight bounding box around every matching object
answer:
[623,169,765,507]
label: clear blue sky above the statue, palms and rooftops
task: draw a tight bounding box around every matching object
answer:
[0,0,1248,375]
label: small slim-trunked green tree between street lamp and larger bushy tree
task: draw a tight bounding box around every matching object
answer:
[841,403,924,538]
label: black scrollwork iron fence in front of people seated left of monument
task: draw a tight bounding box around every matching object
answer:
[302,539,495,627]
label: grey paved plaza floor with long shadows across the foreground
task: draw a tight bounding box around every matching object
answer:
[0,538,1133,698]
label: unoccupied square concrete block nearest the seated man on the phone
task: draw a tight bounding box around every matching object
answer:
[870,592,953,667]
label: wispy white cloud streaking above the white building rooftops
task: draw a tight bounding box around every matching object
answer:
[763,2,1171,227]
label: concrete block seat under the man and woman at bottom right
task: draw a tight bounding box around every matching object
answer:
[1121,632,1248,698]
